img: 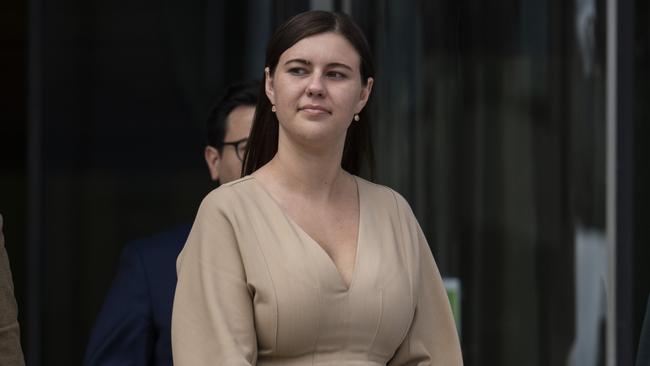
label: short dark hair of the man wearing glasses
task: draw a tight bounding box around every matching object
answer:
[205,81,260,152]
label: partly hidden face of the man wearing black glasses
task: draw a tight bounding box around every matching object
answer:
[217,106,255,184]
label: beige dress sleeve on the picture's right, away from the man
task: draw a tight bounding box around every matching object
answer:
[388,197,463,366]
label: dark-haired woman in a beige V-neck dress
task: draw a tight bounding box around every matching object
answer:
[172,11,462,366]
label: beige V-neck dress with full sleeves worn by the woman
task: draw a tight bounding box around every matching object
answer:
[172,176,462,366]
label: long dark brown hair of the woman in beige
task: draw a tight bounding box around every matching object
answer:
[242,10,375,178]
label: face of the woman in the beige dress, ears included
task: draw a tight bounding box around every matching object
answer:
[265,32,373,149]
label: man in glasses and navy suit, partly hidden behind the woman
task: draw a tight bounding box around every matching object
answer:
[84,82,260,366]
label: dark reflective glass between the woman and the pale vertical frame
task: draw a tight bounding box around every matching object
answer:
[352,0,607,365]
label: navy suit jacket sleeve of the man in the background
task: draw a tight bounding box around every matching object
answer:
[83,244,154,365]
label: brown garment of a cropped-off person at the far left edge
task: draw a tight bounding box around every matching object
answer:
[0,216,25,366]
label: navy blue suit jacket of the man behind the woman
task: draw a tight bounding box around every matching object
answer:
[84,225,190,366]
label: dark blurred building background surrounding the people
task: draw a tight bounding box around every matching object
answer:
[0,0,650,366]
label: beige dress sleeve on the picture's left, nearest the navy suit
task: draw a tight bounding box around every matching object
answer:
[172,187,257,366]
